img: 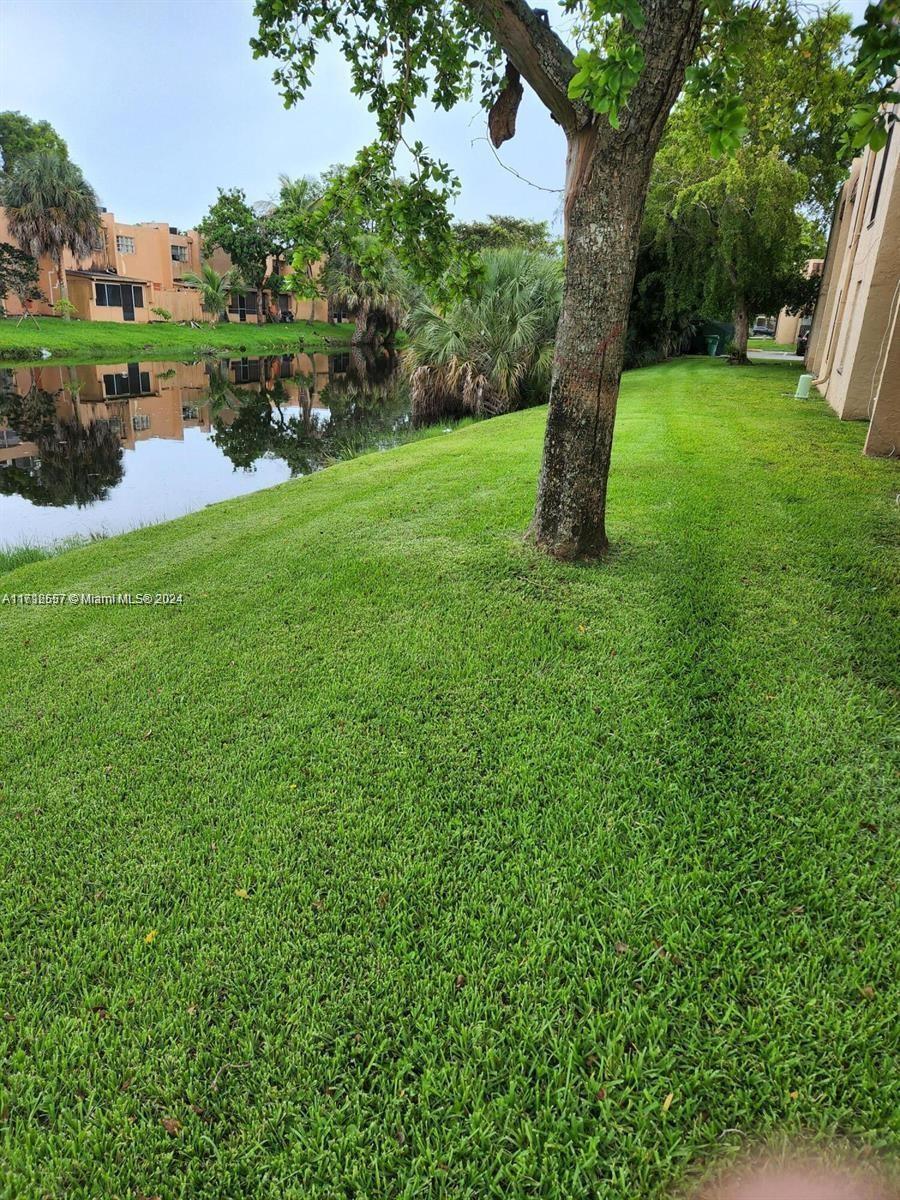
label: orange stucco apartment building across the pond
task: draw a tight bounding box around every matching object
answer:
[0,209,329,324]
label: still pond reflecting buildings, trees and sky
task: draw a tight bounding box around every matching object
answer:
[0,350,410,547]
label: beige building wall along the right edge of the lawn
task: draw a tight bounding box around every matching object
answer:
[806,106,900,456]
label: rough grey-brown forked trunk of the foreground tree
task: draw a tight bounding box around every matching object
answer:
[528,0,704,559]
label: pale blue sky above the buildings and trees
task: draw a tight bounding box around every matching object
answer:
[0,0,865,236]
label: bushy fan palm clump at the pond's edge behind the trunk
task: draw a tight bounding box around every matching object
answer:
[404,250,563,425]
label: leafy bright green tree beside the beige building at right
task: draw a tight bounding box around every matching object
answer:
[644,4,854,362]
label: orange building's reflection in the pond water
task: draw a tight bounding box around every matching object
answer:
[0,354,349,470]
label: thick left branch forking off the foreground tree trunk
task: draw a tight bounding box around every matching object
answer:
[463,0,593,133]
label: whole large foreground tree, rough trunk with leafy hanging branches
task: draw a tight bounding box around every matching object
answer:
[252,0,896,558]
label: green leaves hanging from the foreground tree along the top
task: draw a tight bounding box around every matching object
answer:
[251,0,900,307]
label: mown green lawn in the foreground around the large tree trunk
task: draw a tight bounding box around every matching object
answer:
[0,359,900,1200]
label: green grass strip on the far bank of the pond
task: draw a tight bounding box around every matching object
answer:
[0,317,353,362]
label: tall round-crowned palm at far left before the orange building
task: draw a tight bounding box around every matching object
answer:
[0,150,100,316]
